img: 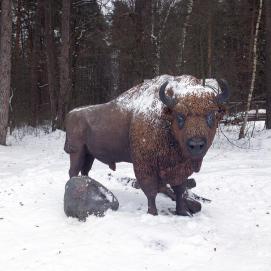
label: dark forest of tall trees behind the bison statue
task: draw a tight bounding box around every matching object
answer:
[0,0,271,143]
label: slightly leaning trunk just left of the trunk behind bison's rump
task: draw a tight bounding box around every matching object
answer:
[43,0,57,131]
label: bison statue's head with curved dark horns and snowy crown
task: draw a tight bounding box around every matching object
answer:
[159,79,229,171]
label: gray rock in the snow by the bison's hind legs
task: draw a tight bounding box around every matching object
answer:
[64,176,119,221]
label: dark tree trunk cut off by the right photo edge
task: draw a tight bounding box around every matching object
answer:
[265,0,271,129]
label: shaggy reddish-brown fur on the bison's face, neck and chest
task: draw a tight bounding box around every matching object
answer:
[130,92,221,214]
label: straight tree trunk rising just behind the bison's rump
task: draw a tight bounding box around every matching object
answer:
[57,0,72,129]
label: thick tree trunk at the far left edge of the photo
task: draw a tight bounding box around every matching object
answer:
[0,0,12,145]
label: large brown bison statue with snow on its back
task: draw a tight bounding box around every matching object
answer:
[64,75,229,216]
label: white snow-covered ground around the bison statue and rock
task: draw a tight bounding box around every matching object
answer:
[0,124,271,271]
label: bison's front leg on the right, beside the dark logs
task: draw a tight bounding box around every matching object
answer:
[172,182,192,216]
